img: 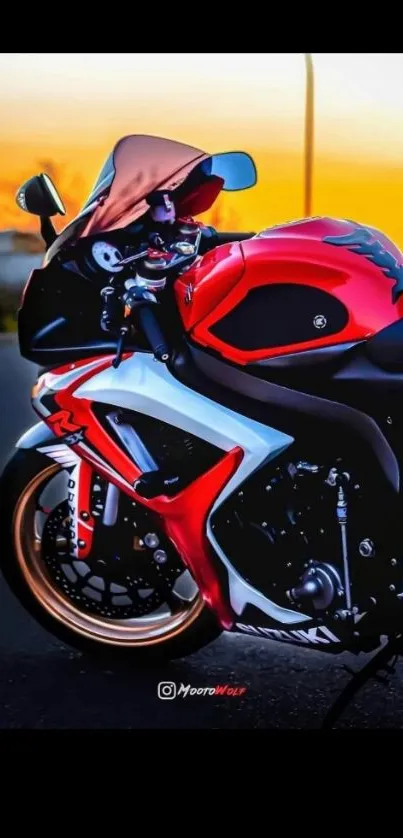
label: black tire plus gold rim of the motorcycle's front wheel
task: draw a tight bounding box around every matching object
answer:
[0,449,221,662]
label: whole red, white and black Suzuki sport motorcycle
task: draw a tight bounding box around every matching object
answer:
[1,136,403,720]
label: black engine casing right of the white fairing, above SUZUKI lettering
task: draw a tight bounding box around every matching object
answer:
[212,458,403,623]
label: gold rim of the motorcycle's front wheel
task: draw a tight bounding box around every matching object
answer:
[13,465,204,647]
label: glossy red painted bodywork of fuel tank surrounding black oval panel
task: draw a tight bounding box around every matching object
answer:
[176,218,403,364]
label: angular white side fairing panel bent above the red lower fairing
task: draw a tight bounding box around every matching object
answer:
[75,354,311,624]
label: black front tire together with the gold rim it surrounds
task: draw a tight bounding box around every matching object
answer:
[0,449,222,663]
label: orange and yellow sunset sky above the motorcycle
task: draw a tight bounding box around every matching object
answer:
[0,53,403,247]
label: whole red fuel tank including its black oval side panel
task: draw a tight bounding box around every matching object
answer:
[175,217,403,365]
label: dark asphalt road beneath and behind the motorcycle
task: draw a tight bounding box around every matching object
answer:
[0,340,403,730]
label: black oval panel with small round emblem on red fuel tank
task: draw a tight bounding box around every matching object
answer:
[210,283,348,351]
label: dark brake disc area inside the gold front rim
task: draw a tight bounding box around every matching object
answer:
[42,500,185,619]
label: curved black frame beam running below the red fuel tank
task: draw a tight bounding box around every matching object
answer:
[173,345,400,492]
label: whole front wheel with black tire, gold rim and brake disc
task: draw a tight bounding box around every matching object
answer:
[0,450,221,660]
